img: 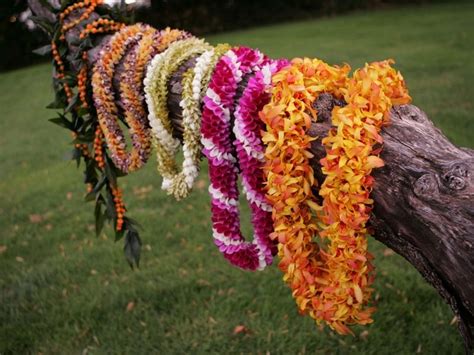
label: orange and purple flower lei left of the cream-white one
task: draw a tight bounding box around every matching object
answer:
[92,24,182,173]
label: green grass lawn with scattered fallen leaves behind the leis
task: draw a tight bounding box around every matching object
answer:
[0,3,474,354]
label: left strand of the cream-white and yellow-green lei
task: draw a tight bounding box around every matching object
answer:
[144,37,212,200]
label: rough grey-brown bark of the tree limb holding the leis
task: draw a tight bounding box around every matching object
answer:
[29,0,474,353]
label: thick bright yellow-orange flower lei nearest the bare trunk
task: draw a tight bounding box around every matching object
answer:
[261,59,409,334]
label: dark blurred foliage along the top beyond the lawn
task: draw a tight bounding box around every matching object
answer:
[0,0,460,71]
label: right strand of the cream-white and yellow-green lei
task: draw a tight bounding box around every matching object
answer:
[174,44,230,198]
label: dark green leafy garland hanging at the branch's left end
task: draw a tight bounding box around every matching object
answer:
[28,0,141,268]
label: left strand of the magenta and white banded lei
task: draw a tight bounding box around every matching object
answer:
[201,47,272,270]
